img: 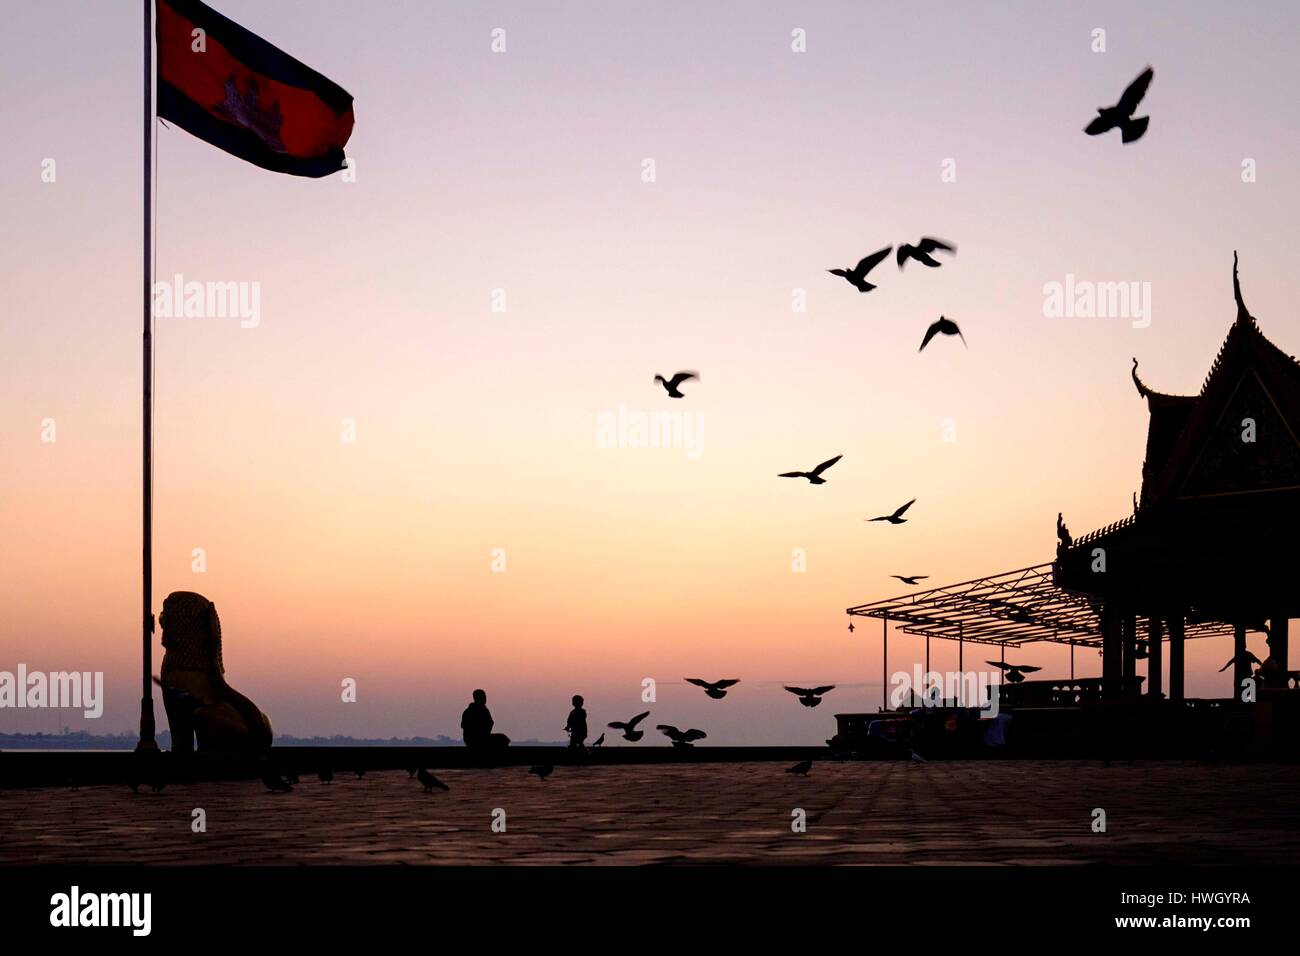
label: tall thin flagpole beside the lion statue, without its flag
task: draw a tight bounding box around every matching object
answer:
[135,0,159,750]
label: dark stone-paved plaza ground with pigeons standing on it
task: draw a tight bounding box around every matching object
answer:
[0,761,1300,866]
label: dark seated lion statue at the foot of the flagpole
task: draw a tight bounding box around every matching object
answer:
[157,591,270,753]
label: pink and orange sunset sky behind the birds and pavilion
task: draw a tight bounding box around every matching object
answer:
[0,0,1300,744]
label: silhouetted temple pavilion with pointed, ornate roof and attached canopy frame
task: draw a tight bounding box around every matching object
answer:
[848,255,1300,704]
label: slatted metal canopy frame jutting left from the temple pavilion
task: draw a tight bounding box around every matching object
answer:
[846,562,1232,648]
